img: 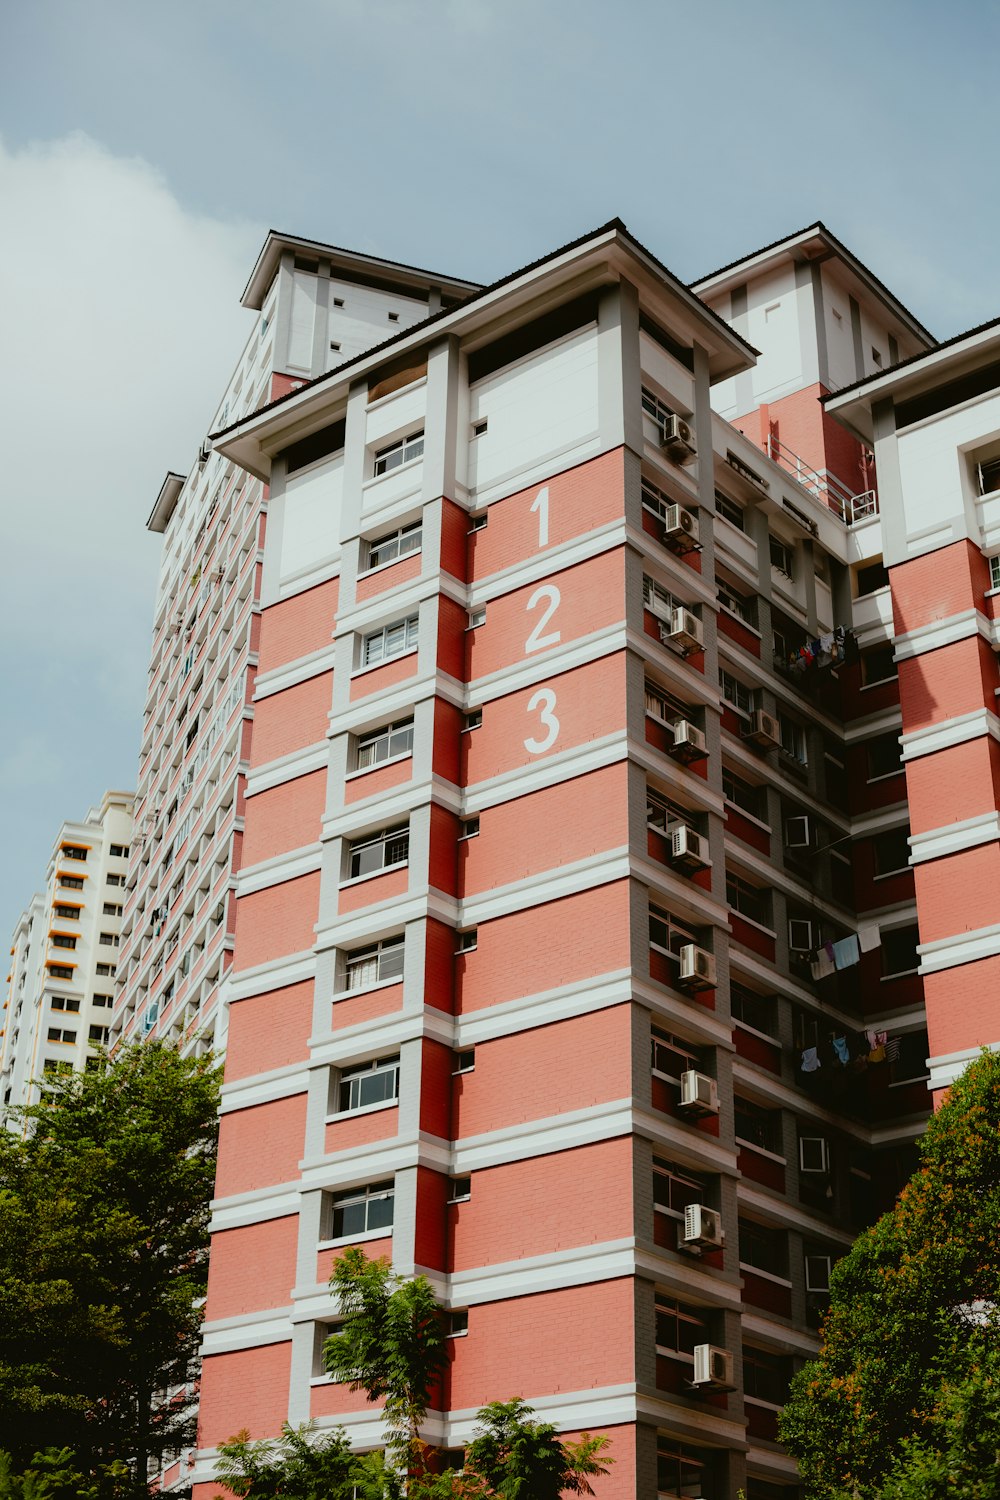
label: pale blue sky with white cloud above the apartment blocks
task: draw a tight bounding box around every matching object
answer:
[0,0,1000,930]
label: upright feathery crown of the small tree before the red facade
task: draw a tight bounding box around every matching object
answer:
[324,1245,447,1467]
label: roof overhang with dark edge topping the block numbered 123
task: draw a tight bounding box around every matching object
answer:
[211,219,757,483]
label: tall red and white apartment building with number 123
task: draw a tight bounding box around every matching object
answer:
[120,221,1000,1500]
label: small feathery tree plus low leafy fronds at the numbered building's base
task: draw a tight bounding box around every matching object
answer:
[220,1247,613,1500]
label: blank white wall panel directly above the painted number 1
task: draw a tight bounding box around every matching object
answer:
[469,324,598,489]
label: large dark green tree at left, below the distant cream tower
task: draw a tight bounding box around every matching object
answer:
[0,1043,219,1494]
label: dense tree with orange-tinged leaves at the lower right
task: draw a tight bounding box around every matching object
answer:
[781,1052,1000,1500]
